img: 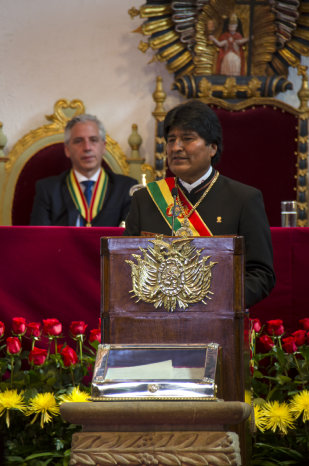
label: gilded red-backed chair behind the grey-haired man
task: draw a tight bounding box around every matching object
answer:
[0,99,151,225]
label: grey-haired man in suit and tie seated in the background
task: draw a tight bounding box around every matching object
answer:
[30,114,137,226]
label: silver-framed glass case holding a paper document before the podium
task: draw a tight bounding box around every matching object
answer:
[91,343,219,401]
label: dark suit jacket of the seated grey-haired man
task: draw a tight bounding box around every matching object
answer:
[30,171,137,227]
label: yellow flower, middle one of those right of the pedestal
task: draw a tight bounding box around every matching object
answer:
[263,401,294,434]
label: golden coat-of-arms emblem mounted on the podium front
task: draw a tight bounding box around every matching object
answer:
[126,236,216,312]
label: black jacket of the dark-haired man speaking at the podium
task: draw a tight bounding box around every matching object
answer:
[124,175,275,307]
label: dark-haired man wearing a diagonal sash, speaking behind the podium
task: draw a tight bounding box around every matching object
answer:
[124,100,275,308]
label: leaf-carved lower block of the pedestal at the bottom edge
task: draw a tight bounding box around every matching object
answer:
[70,431,241,466]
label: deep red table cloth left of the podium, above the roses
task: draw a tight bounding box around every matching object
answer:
[0,227,123,331]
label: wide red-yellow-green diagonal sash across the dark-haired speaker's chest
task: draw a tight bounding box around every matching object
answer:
[147,177,213,236]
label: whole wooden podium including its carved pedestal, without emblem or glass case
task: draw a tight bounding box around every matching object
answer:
[61,236,251,466]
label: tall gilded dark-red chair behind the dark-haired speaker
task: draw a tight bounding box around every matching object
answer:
[153,75,309,226]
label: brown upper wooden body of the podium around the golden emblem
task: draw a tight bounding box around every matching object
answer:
[101,236,249,401]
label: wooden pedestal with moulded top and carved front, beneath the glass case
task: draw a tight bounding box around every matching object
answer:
[60,401,251,466]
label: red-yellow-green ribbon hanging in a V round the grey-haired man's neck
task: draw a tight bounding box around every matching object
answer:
[66,168,108,226]
